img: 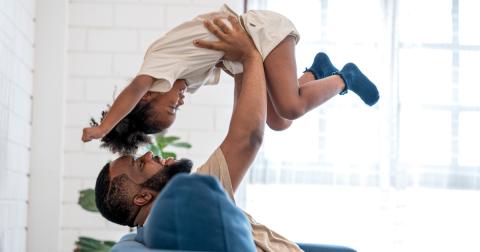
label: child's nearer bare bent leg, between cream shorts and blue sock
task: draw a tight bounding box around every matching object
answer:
[264,36,345,120]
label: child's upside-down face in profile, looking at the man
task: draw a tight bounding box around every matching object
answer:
[147,80,187,129]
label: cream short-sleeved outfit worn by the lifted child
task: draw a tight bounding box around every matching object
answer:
[138,5,300,93]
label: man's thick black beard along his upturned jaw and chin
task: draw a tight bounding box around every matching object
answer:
[141,158,193,192]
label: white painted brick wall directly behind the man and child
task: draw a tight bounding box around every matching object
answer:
[63,0,242,251]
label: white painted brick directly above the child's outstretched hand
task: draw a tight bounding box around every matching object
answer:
[66,102,107,128]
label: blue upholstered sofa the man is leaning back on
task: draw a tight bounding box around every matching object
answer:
[112,174,354,252]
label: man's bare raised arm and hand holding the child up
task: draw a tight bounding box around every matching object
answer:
[195,17,267,191]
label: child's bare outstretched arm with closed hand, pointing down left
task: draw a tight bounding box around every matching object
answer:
[82,75,154,142]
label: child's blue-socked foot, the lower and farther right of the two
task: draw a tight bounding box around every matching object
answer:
[338,63,380,106]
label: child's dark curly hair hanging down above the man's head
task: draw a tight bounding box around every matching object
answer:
[90,102,162,155]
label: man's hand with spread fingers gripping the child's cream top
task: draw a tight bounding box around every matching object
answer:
[193,16,259,62]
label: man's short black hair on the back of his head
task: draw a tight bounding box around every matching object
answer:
[95,162,136,227]
